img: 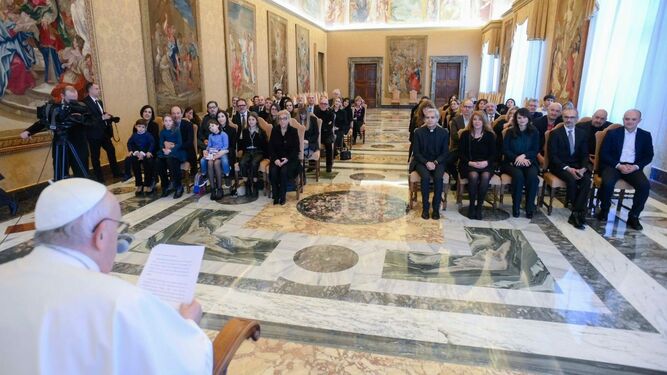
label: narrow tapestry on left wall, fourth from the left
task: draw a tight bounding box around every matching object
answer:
[268,12,289,92]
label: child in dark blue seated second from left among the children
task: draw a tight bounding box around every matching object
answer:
[157,115,186,198]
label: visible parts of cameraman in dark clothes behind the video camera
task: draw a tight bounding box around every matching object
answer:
[21,86,88,177]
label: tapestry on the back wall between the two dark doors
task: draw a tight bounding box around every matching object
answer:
[384,36,428,98]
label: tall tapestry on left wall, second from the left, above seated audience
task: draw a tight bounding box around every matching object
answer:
[140,0,202,113]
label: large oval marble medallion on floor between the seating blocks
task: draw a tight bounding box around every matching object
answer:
[296,191,407,224]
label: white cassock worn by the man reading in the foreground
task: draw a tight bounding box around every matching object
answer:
[0,246,213,375]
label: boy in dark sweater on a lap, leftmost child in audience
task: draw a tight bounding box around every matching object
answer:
[127,119,157,195]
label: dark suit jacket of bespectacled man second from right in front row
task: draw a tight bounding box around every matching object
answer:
[547,126,591,170]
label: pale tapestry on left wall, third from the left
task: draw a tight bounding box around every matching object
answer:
[225,0,257,99]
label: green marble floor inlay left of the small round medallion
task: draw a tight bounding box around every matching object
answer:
[132,209,280,264]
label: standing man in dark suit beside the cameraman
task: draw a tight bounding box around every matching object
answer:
[83,82,122,183]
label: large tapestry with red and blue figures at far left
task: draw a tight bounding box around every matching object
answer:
[0,0,98,116]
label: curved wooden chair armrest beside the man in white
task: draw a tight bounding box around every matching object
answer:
[213,318,260,375]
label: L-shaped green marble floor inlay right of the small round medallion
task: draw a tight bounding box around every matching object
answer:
[382,227,557,292]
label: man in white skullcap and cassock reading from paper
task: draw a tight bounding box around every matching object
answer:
[0,178,213,374]
